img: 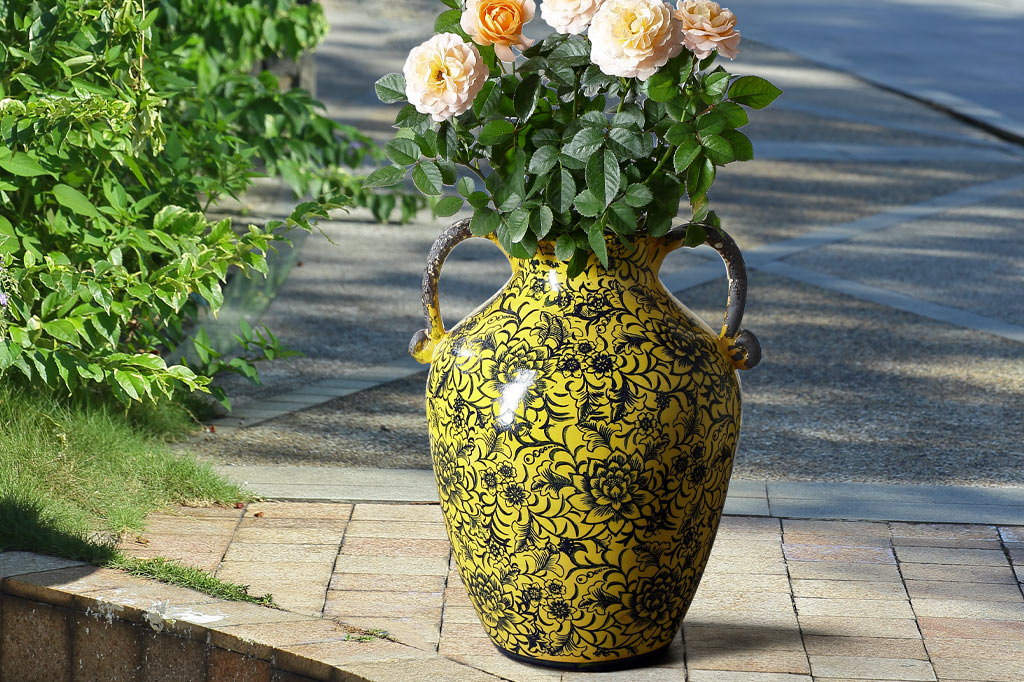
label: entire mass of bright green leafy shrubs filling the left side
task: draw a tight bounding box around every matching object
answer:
[0,0,407,402]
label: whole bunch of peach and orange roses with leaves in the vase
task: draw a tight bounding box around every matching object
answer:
[366,0,781,275]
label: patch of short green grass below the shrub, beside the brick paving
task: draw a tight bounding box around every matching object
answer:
[0,385,273,606]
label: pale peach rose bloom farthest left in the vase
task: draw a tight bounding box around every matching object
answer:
[402,33,488,121]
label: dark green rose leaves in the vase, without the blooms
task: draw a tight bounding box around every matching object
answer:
[370,7,781,274]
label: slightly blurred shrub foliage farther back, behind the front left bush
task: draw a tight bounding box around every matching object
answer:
[147,0,427,221]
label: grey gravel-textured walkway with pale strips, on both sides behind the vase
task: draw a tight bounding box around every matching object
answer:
[186,0,1024,486]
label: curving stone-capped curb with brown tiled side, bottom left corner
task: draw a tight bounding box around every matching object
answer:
[0,552,499,682]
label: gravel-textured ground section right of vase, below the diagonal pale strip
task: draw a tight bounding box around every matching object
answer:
[684,272,1024,485]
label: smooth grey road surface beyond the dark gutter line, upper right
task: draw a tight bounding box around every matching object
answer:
[724,0,1024,138]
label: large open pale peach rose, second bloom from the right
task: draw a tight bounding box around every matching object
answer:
[589,0,683,81]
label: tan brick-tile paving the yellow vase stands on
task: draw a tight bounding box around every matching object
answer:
[108,502,1024,682]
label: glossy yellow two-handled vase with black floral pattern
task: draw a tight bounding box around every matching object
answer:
[410,221,760,670]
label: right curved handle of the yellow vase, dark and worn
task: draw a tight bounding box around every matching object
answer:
[665,223,761,370]
